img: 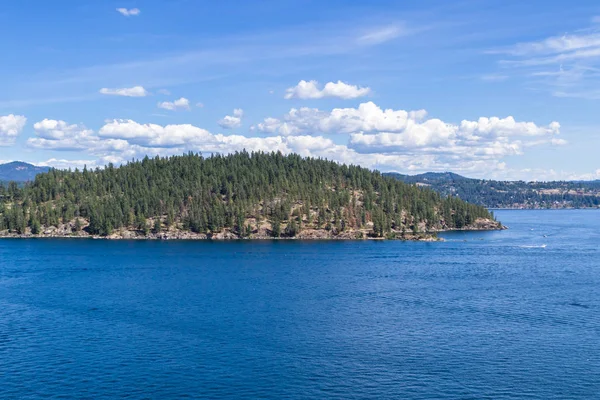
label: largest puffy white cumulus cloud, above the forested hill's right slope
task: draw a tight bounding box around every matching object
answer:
[253,102,566,163]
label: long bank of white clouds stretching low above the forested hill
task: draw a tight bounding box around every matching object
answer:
[27,102,566,175]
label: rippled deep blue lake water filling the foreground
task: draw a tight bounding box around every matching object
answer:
[0,210,600,399]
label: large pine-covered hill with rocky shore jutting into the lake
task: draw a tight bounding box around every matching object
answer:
[0,151,503,240]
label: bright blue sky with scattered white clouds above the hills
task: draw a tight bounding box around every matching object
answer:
[0,0,600,180]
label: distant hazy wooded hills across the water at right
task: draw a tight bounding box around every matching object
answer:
[384,172,600,208]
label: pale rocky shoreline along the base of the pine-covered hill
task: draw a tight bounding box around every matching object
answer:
[0,220,507,242]
